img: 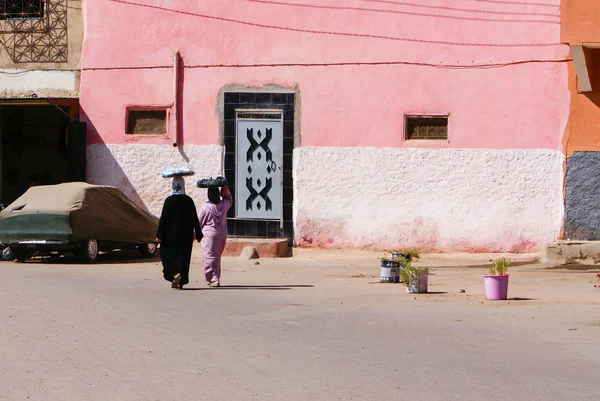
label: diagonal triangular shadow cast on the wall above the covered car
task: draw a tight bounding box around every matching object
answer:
[81,107,150,212]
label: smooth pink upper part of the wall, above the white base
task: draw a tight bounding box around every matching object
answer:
[81,0,568,149]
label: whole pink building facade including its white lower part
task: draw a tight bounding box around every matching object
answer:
[80,0,569,250]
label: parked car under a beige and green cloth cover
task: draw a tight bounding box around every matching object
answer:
[0,182,158,263]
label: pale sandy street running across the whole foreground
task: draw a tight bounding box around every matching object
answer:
[0,250,600,401]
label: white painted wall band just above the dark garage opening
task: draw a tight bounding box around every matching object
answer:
[0,69,79,97]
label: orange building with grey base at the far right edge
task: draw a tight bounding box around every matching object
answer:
[561,0,600,240]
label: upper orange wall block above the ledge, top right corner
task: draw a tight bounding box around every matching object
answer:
[561,0,600,46]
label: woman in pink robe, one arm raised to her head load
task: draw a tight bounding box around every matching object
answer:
[198,186,233,287]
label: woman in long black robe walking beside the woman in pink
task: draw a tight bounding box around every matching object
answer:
[156,177,202,290]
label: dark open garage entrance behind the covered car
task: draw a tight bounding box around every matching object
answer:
[0,100,86,206]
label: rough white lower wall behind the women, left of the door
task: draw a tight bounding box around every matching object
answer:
[87,144,223,216]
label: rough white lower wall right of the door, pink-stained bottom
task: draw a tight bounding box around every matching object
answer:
[294,147,564,252]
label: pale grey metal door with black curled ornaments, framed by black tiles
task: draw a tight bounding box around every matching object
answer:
[235,110,283,220]
